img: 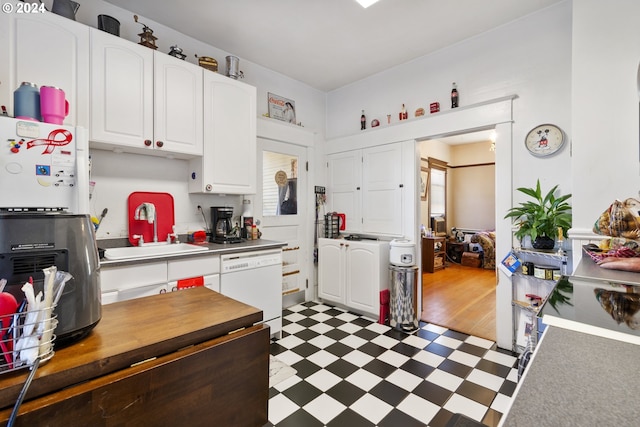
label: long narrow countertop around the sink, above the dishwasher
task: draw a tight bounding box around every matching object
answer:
[98,239,287,267]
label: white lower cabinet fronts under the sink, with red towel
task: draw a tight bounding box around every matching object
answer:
[100,255,220,305]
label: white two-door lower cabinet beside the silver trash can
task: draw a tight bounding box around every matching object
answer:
[318,238,389,317]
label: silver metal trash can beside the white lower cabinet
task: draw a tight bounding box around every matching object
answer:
[389,264,418,332]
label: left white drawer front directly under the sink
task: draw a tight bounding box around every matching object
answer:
[100,261,167,292]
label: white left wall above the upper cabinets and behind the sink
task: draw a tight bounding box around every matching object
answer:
[60,0,326,239]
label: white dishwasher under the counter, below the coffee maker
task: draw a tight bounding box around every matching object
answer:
[220,249,282,336]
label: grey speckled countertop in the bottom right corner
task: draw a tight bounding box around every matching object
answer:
[501,326,640,427]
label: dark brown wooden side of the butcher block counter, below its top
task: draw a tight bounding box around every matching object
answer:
[0,325,269,426]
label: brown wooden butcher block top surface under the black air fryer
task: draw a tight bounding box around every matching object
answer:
[0,287,262,408]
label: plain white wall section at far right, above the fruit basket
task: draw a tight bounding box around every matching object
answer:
[572,0,640,241]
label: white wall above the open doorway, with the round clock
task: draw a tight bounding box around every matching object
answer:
[326,1,571,194]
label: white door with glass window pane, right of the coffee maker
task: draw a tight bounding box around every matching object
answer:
[253,138,313,301]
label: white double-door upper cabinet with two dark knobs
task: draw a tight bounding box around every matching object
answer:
[89,29,203,157]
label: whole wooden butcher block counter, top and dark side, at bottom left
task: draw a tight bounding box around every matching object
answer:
[0,287,269,427]
